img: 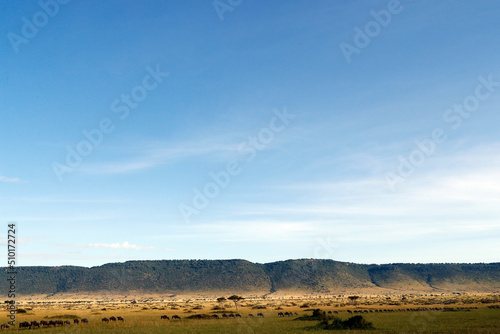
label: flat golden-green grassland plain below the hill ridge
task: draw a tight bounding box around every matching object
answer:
[0,294,500,334]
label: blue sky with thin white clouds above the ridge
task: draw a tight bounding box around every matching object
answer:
[0,0,500,266]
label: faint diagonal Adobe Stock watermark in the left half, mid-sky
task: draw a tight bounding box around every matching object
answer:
[52,65,169,182]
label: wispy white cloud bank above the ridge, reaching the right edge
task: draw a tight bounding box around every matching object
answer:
[182,145,500,249]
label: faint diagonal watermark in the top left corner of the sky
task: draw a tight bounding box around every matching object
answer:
[7,0,71,53]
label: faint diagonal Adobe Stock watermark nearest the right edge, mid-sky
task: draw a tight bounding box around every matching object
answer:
[385,73,500,191]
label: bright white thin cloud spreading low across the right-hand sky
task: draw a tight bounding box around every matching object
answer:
[202,145,500,238]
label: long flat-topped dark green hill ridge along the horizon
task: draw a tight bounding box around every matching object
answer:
[0,259,500,295]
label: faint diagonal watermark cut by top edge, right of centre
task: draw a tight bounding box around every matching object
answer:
[339,0,411,64]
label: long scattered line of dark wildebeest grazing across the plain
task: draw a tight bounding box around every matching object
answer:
[0,306,484,329]
